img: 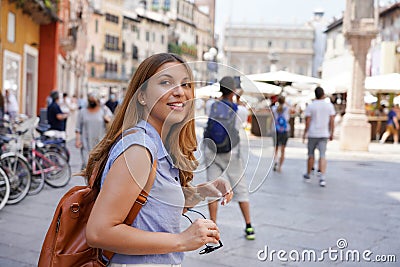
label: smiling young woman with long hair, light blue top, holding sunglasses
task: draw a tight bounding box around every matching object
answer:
[83,53,232,266]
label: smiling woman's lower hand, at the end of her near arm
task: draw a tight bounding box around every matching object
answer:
[179,219,220,251]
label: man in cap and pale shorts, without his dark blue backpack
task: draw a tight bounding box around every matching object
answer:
[205,76,255,240]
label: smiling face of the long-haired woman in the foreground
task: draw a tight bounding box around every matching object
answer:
[138,62,193,133]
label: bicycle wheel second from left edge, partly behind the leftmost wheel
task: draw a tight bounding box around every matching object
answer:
[1,152,32,204]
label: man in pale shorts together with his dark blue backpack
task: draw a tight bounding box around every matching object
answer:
[204,76,255,240]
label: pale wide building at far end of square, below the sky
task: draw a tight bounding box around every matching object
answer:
[223,25,314,76]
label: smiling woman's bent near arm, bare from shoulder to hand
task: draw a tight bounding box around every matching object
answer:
[86,146,219,255]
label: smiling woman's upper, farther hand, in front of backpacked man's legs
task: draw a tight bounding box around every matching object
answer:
[196,177,233,205]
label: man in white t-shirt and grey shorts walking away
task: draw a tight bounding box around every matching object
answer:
[303,87,335,187]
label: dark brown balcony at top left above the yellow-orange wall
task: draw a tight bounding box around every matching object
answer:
[8,0,60,25]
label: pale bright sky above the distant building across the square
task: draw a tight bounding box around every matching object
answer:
[215,0,395,37]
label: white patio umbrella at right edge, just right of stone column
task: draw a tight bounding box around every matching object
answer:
[365,73,400,93]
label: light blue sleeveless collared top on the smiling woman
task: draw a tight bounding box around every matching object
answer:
[101,121,185,264]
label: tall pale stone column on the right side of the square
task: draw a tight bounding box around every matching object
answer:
[340,0,377,151]
